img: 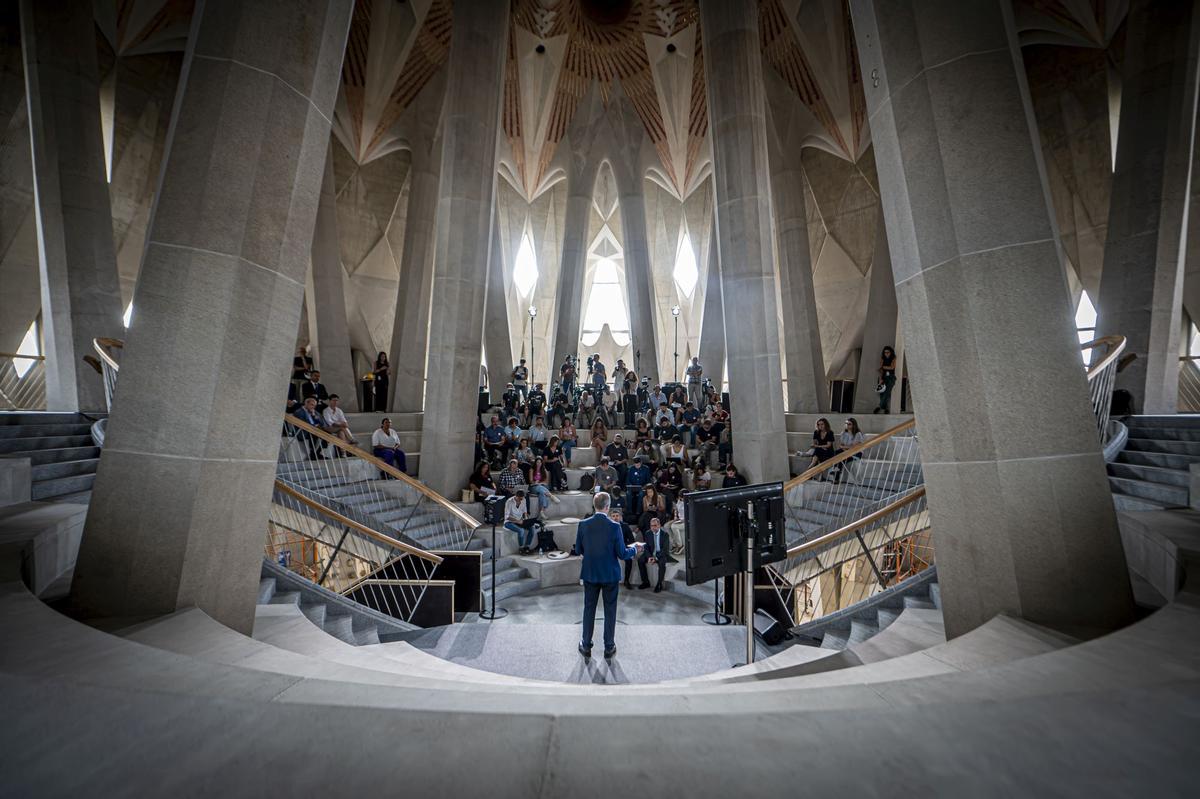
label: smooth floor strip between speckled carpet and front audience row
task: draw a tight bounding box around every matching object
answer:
[470,578,713,627]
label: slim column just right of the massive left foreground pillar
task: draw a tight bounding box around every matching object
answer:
[312,139,355,413]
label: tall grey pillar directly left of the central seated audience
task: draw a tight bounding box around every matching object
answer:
[421,0,509,495]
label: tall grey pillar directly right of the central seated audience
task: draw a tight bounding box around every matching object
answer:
[700,0,790,482]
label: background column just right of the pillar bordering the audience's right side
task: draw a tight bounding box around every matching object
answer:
[770,143,829,413]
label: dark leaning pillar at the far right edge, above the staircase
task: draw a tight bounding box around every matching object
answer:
[1097,0,1200,414]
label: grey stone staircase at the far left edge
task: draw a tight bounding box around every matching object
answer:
[0,411,100,503]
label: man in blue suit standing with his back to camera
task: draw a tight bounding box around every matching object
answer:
[575,491,642,657]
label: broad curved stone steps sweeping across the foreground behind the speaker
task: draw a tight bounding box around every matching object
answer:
[0,511,1200,795]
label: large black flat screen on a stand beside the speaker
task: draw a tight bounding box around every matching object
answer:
[683,482,787,585]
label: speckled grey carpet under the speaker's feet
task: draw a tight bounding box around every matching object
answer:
[403,614,745,684]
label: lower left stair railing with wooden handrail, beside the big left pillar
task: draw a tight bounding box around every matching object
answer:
[265,480,442,621]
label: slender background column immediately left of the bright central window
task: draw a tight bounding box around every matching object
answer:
[550,158,597,379]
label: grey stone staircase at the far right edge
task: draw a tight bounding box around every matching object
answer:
[1108,415,1200,511]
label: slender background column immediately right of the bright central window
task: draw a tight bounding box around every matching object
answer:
[614,169,664,383]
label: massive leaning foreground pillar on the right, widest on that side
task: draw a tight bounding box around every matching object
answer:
[851,0,1132,636]
